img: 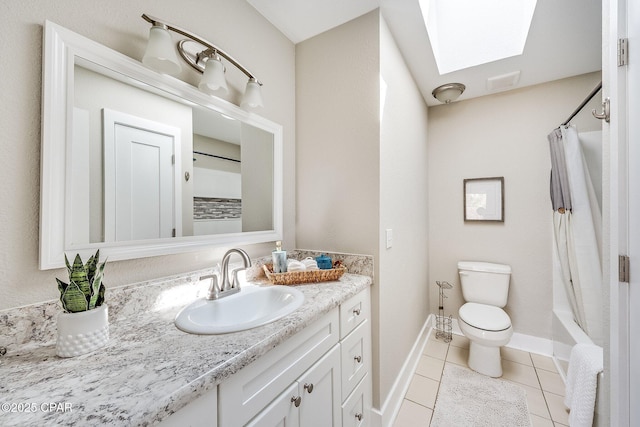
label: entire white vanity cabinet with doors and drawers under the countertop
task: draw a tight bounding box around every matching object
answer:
[161,288,372,427]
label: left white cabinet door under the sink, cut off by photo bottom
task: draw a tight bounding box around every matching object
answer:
[246,383,302,427]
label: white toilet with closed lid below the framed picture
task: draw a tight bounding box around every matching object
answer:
[458,261,513,378]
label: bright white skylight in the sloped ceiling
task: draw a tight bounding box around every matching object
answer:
[419,0,536,74]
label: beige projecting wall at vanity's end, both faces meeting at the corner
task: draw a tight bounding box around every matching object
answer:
[296,11,428,408]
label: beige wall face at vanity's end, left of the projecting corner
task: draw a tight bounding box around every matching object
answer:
[296,12,381,406]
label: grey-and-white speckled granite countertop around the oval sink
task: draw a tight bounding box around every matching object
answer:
[0,252,372,426]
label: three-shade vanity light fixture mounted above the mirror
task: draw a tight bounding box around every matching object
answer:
[142,14,263,108]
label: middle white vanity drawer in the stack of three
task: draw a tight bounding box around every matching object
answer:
[340,320,371,397]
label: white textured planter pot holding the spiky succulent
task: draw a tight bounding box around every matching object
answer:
[56,304,109,357]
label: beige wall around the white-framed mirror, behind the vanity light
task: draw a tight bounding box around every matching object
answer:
[0,0,295,309]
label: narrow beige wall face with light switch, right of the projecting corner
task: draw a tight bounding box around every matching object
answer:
[378,15,430,412]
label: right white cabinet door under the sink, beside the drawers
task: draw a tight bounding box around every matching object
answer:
[298,346,342,427]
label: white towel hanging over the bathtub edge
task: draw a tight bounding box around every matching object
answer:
[564,344,603,427]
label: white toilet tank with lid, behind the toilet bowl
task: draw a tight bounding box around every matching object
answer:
[458,261,511,307]
